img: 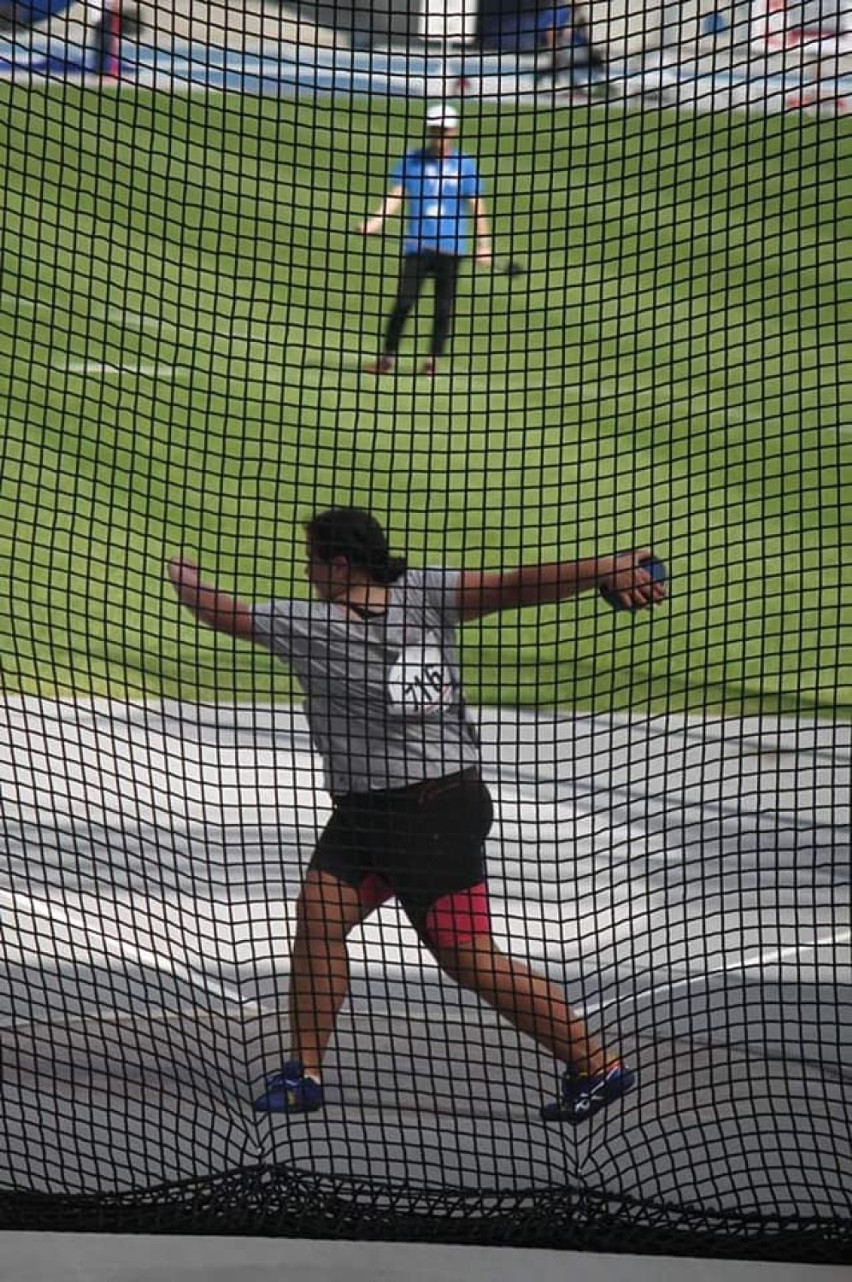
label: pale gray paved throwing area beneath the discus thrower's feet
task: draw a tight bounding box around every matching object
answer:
[0,699,852,1217]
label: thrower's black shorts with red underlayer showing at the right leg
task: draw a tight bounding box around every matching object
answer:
[310,769,493,942]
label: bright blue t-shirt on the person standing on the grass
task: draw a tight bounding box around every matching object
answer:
[391,147,482,254]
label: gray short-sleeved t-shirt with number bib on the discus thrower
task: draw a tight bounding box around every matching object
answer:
[252,569,479,796]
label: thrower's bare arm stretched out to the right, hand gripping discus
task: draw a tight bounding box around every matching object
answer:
[457,547,666,619]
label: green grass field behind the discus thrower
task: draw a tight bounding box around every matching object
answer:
[0,86,852,719]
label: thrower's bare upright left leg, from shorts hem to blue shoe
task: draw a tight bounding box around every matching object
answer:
[290,870,373,1081]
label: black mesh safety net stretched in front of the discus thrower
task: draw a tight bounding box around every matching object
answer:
[0,3,852,1261]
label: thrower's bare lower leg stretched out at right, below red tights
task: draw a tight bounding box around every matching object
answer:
[428,935,607,1073]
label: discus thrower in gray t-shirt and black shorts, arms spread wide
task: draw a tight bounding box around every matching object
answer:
[169,508,665,1124]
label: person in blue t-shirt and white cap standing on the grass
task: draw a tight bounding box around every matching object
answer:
[357,104,491,376]
